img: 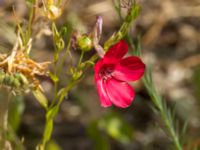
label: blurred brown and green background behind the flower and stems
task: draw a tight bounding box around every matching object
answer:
[0,0,200,150]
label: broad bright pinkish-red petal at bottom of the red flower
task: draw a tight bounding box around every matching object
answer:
[106,79,135,108]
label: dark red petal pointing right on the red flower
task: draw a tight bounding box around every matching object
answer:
[113,56,145,81]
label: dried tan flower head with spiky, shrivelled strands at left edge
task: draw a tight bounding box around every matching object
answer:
[0,36,49,91]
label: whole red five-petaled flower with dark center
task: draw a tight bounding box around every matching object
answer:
[94,41,145,108]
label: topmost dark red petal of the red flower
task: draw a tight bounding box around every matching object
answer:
[104,40,128,59]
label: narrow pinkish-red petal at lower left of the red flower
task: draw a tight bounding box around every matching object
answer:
[95,79,112,107]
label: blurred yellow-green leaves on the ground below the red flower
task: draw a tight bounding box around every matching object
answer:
[88,112,133,150]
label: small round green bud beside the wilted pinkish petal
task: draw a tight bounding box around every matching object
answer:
[77,36,93,52]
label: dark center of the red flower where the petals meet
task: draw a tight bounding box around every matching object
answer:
[99,66,114,80]
